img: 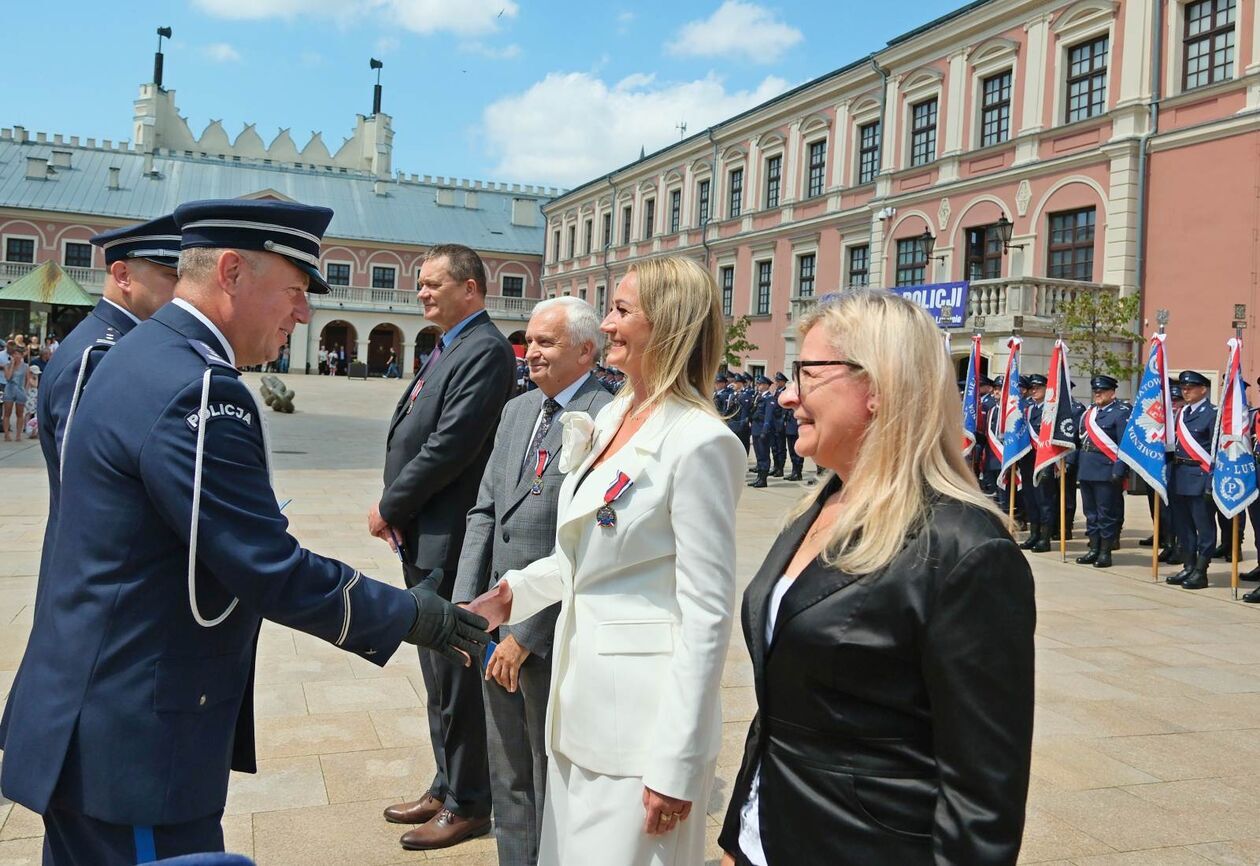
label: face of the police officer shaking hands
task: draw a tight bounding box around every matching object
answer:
[224,251,311,367]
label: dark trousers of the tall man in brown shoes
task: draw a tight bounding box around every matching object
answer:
[403,565,490,818]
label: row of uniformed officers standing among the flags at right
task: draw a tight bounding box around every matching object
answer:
[960,371,1260,594]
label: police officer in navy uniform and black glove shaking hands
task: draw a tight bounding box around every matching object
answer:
[0,200,488,866]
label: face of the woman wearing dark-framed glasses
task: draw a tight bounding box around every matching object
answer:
[779,325,877,478]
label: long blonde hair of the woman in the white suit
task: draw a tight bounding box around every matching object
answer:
[629,256,726,415]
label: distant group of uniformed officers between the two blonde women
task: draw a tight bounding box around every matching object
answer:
[713,373,805,488]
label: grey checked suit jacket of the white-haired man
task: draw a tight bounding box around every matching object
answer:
[452,376,612,658]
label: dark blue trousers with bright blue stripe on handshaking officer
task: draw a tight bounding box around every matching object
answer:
[44,805,223,866]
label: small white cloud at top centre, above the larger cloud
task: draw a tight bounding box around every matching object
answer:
[665,0,805,63]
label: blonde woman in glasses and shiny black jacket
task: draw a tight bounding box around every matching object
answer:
[719,290,1036,866]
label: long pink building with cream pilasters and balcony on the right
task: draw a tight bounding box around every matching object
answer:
[542,0,1260,397]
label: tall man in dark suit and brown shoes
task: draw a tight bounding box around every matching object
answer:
[368,243,517,850]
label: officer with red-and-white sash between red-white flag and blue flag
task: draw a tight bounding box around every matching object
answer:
[1076,376,1129,569]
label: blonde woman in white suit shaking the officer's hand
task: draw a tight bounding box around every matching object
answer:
[473,257,746,866]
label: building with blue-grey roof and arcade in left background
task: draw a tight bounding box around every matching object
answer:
[0,67,558,376]
